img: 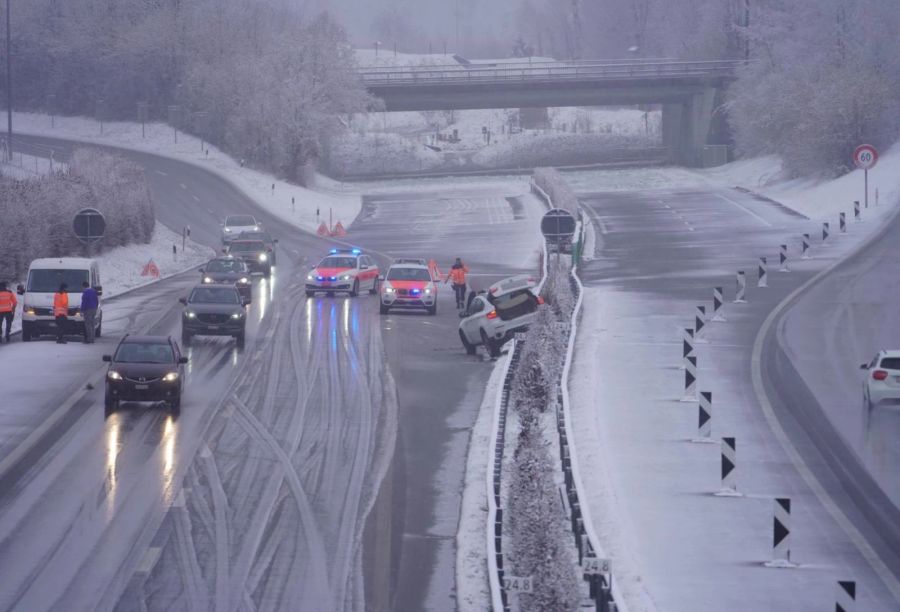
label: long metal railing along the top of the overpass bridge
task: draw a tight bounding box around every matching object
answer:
[358,60,745,87]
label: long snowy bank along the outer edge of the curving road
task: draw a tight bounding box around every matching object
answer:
[0,112,362,233]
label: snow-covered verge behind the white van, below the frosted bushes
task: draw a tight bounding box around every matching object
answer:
[12,221,216,332]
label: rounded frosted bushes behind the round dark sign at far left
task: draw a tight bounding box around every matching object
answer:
[0,149,156,280]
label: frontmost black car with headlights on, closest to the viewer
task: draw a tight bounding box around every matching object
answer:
[103,335,188,414]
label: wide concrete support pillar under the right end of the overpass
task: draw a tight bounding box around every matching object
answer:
[662,87,716,166]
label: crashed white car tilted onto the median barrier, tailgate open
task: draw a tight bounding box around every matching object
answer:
[459,276,544,357]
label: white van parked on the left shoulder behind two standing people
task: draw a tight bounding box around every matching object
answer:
[16,257,103,342]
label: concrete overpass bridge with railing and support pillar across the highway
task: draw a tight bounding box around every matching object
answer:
[359,60,741,165]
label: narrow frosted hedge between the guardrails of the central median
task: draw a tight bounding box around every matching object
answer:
[505,263,581,611]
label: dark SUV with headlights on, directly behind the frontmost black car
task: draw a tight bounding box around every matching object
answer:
[179,284,247,346]
